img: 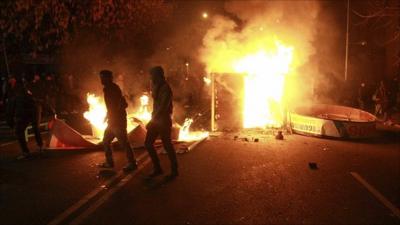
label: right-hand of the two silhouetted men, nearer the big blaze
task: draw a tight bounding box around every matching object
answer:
[145,66,178,180]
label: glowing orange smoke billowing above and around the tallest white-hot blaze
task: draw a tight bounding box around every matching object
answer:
[199,1,341,104]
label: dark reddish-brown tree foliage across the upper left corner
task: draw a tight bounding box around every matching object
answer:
[0,0,172,53]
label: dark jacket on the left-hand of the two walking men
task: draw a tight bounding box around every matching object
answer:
[103,83,128,126]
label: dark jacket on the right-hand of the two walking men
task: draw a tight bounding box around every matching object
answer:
[151,82,173,122]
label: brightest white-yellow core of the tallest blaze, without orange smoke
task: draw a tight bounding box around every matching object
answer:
[233,41,293,128]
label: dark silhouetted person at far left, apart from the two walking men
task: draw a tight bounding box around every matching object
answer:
[7,81,43,159]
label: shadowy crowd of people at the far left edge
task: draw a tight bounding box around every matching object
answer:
[0,73,83,159]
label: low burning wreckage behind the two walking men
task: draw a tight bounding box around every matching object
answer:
[49,94,208,153]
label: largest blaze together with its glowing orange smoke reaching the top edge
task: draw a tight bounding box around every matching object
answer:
[199,1,320,128]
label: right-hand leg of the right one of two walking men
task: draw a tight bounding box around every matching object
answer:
[160,123,178,176]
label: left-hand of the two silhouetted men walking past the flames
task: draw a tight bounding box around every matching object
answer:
[99,70,137,172]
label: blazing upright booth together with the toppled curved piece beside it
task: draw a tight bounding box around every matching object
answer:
[205,39,377,139]
